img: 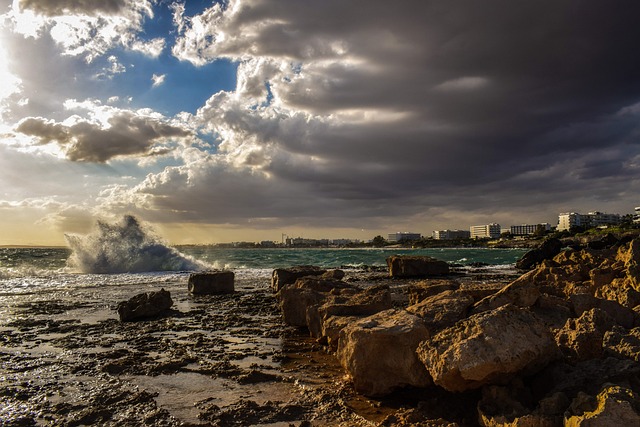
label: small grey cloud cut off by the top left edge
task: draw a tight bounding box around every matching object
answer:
[19,0,128,16]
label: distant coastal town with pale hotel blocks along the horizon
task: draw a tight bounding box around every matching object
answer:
[206,206,640,248]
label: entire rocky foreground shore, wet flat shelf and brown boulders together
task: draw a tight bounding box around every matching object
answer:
[0,238,640,427]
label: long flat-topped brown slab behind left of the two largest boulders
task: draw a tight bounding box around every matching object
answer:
[307,285,392,337]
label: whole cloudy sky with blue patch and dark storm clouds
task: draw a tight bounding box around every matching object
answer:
[0,0,640,245]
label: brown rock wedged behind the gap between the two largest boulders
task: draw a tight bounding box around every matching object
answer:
[407,290,473,333]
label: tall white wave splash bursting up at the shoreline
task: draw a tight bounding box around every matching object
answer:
[64,215,207,274]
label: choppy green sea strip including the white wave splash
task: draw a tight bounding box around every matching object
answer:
[0,216,525,296]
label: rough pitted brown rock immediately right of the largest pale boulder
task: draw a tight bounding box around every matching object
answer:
[556,308,615,360]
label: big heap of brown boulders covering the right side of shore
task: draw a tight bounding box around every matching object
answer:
[273,236,640,426]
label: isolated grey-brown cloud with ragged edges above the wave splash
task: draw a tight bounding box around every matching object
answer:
[16,111,190,163]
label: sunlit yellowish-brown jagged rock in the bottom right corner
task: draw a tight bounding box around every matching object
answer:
[564,385,640,427]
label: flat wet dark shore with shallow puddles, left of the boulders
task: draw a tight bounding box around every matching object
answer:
[0,272,516,427]
